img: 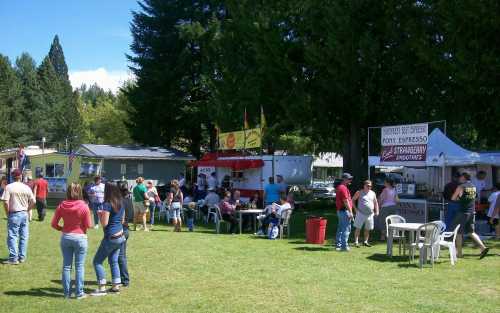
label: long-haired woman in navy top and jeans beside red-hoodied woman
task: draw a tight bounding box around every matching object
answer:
[91,183,125,296]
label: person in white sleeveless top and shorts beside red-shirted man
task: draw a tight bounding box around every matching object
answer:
[352,180,379,248]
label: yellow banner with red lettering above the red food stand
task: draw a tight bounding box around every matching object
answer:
[219,128,262,150]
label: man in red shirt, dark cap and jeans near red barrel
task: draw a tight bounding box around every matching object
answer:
[335,173,353,251]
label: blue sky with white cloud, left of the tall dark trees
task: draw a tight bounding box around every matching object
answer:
[0,0,139,89]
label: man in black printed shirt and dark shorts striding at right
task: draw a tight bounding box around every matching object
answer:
[451,173,489,259]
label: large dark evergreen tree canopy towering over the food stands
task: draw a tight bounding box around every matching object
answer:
[127,0,500,180]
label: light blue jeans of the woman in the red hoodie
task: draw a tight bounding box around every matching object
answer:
[61,234,88,298]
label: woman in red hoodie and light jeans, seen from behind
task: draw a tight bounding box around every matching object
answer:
[51,183,92,299]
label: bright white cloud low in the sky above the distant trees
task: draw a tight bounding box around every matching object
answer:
[69,67,133,93]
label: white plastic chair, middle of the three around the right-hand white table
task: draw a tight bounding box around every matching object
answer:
[410,223,440,268]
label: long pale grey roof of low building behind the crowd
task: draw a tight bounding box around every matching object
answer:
[77,144,195,161]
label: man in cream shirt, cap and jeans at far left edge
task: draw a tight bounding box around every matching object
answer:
[1,169,36,265]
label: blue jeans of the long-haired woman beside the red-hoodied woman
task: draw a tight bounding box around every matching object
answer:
[93,236,125,285]
